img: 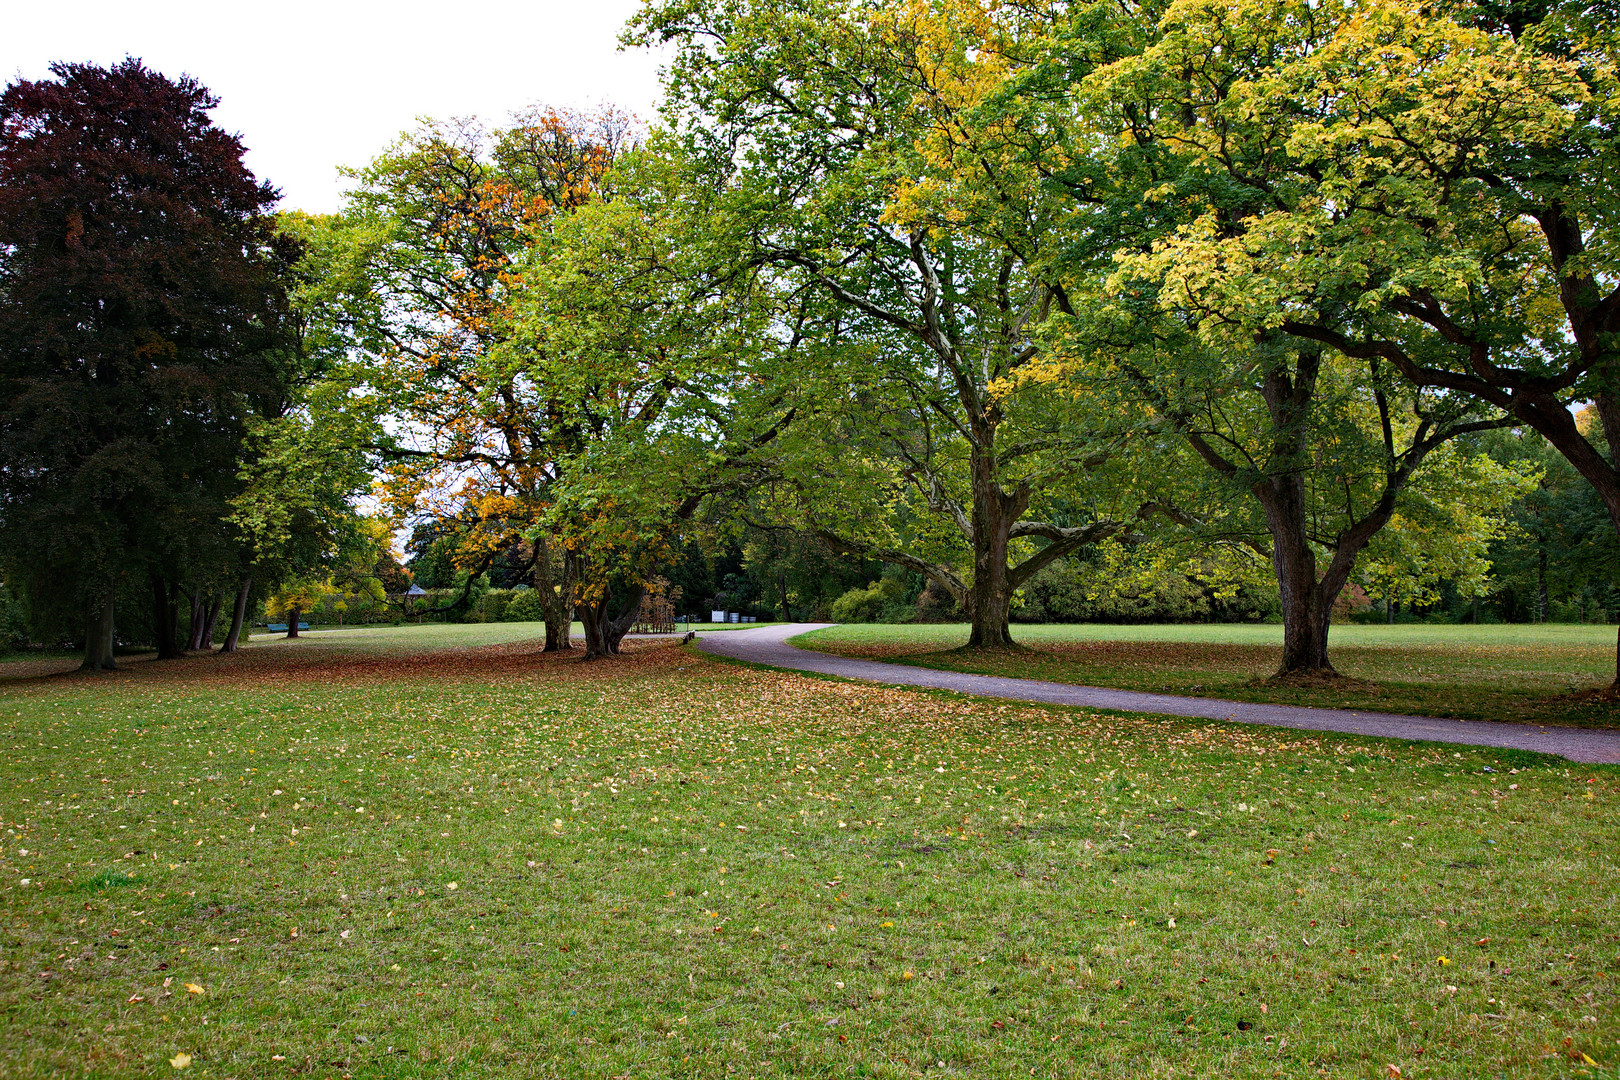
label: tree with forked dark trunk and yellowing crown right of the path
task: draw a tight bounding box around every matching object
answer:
[972,3,1507,675]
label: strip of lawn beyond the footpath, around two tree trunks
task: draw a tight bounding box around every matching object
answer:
[794,623,1620,727]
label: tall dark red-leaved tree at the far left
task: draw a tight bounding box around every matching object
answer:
[0,60,290,669]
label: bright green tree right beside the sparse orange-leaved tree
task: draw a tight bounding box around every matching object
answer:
[492,146,802,659]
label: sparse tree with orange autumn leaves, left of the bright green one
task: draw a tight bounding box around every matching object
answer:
[319,110,632,649]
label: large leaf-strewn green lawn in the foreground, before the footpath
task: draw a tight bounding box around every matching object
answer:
[0,628,1620,1080]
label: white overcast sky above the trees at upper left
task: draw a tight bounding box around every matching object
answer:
[0,0,659,210]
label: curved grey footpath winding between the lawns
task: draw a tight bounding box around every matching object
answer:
[698,622,1620,763]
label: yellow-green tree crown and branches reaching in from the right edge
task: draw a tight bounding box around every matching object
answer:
[1075,0,1620,676]
